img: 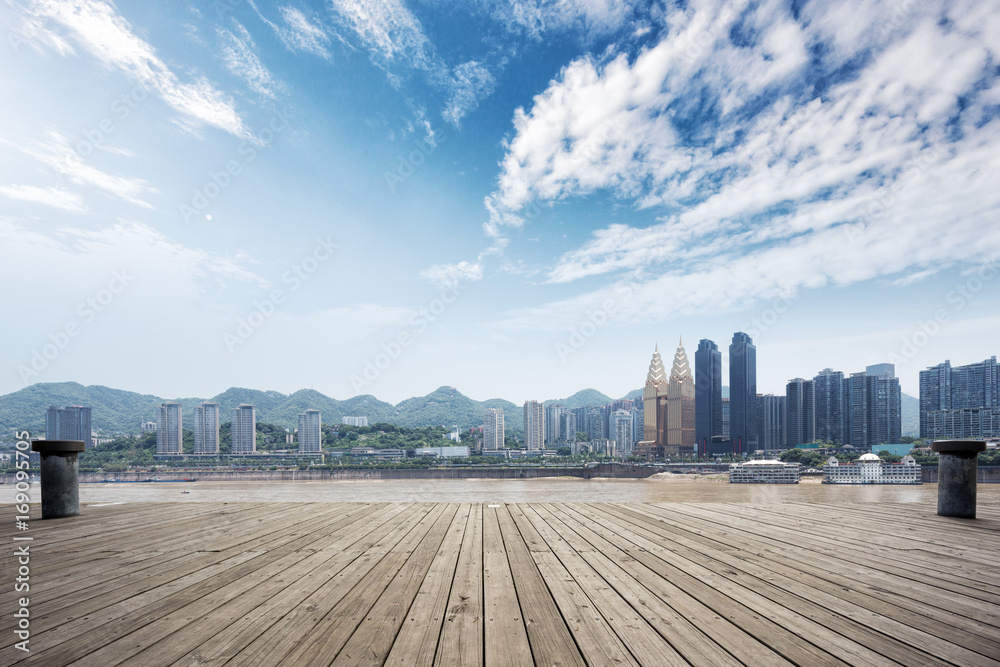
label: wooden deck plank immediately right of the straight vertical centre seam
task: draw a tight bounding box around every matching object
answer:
[483,506,533,667]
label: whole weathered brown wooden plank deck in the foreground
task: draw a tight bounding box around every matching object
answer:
[0,503,1000,667]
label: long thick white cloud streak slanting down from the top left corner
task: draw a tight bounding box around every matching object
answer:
[24,0,247,137]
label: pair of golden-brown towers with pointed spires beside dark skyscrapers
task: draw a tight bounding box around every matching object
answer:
[635,341,697,459]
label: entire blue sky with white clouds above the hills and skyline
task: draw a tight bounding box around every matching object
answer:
[0,0,1000,403]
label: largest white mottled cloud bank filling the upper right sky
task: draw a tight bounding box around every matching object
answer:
[485,0,1000,330]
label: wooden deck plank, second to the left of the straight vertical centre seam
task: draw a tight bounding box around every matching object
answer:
[385,504,472,667]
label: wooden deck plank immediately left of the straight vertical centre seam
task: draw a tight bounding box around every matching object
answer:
[434,504,485,667]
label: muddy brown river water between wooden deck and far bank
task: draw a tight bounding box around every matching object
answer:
[7,475,1000,506]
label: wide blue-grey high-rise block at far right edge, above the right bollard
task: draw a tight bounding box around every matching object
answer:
[920,357,1000,439]
